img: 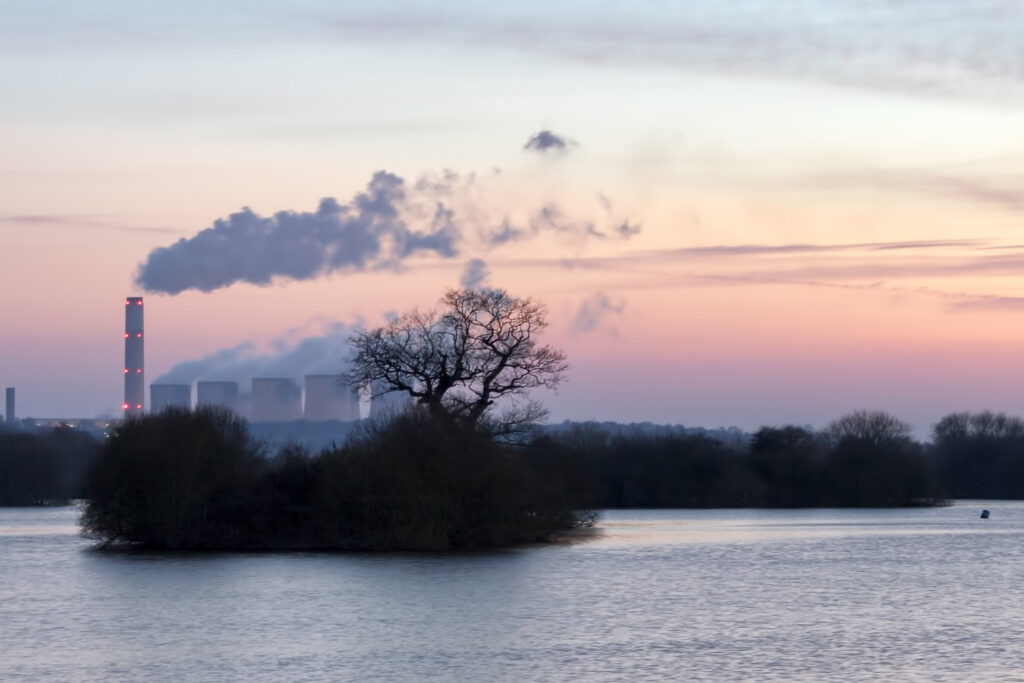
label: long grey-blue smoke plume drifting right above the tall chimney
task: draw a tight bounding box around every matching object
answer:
[135,170,640,294]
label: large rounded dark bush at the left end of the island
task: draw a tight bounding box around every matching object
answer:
[82,408,264,549]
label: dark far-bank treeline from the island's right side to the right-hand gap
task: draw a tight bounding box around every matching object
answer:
[537,412,950,508]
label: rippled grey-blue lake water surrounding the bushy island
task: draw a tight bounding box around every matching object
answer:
[0,502,1024,681]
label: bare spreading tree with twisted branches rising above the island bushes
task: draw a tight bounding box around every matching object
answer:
[345,289,568,433]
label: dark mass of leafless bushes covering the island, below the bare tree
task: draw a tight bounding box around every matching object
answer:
[82,409,593,550]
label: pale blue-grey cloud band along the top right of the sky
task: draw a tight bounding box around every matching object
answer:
[315,0,1024,99]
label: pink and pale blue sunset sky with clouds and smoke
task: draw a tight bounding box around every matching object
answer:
[0,0,1024,436]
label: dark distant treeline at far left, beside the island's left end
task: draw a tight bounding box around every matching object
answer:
[0,427,99,506]
